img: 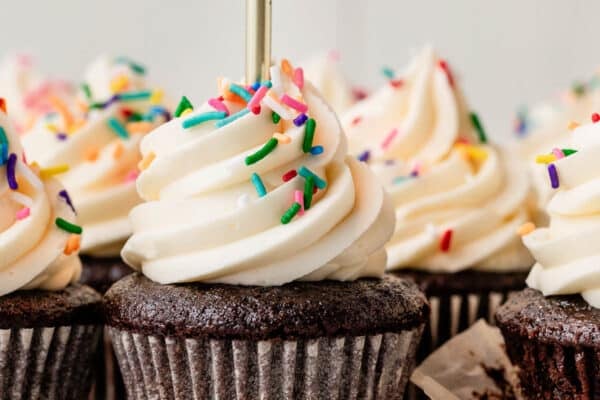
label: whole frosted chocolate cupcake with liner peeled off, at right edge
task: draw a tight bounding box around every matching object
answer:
[497,114,600,399]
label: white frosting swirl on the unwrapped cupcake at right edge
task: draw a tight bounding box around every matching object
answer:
[523,124,600,308]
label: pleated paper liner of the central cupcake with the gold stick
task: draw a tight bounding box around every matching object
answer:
[109,326,423,400]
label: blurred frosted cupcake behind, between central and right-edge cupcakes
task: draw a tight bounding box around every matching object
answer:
[342,48,533,357]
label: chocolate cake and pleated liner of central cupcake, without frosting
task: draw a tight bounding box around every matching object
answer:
[105,274,428,399]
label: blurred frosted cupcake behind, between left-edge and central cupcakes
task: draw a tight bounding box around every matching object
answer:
[24,56,170,399]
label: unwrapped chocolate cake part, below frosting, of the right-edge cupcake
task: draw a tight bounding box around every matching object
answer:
[496,289,600,399]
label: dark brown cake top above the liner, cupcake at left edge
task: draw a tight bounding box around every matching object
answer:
[0,284,102,329]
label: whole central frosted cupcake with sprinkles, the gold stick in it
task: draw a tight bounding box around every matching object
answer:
[105,61,428,399]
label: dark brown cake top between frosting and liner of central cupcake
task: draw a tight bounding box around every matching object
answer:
[104,274,429,340]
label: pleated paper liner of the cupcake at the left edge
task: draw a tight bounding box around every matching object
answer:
[0,325,102,400]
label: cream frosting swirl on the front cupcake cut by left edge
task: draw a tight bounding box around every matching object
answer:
[0,108,81,296]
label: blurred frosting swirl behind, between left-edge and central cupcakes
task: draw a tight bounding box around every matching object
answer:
[23,58,165,256]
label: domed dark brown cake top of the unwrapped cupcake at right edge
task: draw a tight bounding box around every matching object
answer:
[496,289,600,348]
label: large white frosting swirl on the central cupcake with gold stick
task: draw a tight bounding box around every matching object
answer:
[122,66,394,286]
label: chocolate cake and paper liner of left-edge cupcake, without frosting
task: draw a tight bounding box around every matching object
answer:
[0,285,102,400]
